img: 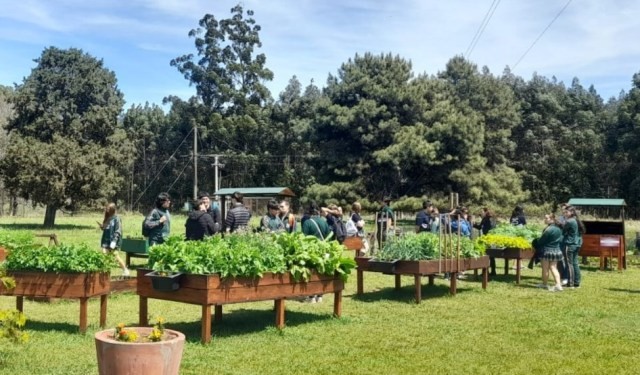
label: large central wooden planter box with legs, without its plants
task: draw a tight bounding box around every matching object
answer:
[137,269,344,343]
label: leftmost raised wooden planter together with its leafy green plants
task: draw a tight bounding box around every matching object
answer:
[0,244,115,332]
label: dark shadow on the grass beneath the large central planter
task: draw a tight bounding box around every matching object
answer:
[168,306,333,342]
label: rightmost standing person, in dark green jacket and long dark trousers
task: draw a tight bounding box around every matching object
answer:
[562,206,585,288]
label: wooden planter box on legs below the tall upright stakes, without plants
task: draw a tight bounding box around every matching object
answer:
[355,256,489,303]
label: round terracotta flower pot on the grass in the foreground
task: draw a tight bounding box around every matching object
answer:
[95,327,184,375]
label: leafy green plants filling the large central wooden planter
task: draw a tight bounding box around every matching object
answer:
[149,232,355,280]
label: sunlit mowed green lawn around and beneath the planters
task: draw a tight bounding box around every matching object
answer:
[0,215,640,375]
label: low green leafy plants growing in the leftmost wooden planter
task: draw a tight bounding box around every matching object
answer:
[6,244,116,273]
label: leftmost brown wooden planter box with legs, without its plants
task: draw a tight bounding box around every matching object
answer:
[0,271,110,333]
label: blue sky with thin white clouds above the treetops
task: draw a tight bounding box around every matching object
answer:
[0,0,640,107]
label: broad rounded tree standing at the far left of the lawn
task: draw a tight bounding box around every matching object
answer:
[0,47,131,227]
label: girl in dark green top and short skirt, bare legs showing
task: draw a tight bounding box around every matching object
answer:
[535,214,562,292]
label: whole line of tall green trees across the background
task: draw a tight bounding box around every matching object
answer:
[0,6,640,226]
